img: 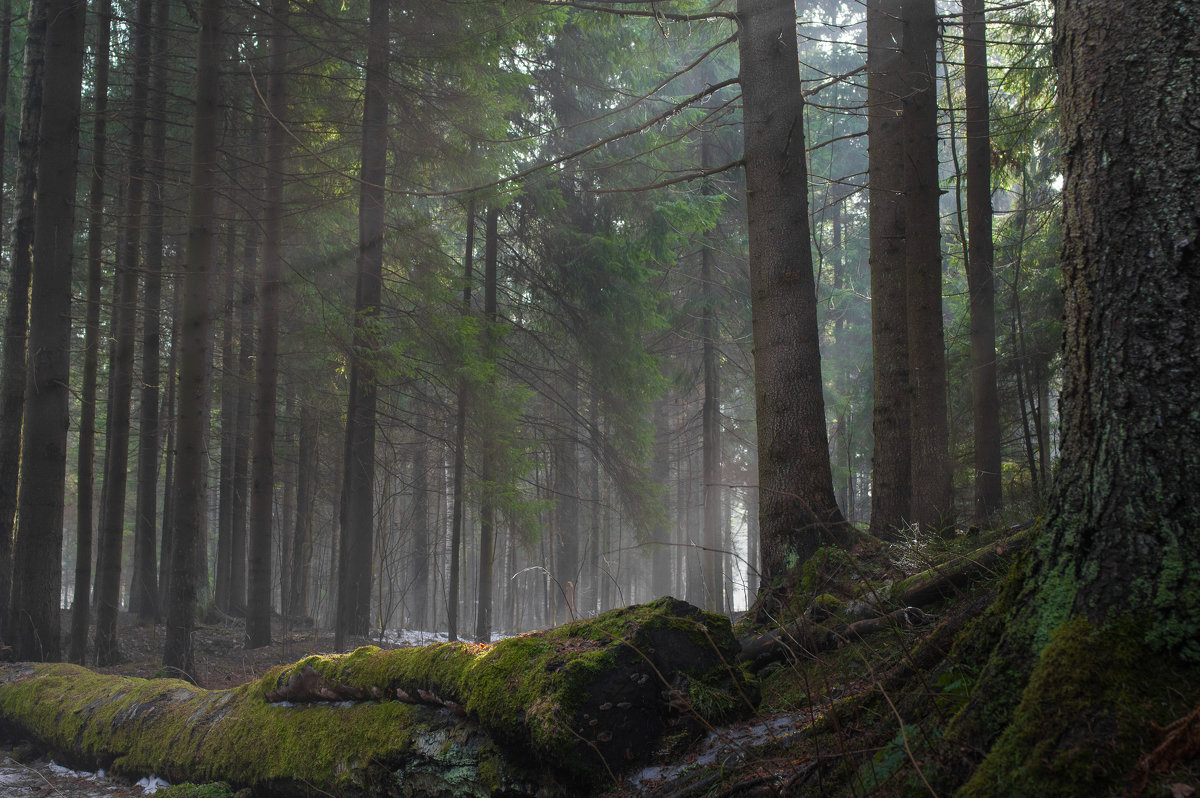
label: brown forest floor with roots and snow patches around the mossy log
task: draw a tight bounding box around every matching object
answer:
[0,525,1041,798]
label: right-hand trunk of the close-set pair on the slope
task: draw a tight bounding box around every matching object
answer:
[901,0,954,533]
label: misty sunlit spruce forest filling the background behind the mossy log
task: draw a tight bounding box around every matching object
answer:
[0,0,1061,672]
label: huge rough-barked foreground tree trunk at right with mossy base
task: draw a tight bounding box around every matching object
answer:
[958,0,1200,796]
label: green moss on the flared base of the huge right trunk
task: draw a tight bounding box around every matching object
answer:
[959,617,1200,798]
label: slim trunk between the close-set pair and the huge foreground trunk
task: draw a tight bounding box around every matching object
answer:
[962,0,1001,524]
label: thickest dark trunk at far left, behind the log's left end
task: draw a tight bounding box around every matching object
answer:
[8,0,85,660]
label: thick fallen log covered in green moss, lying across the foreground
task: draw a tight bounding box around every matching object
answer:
[0,599,756,796]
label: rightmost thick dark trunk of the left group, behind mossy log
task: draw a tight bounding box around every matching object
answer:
[336,0,389,649]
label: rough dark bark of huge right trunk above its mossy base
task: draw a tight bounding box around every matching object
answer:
[1040,0,1200,659]
